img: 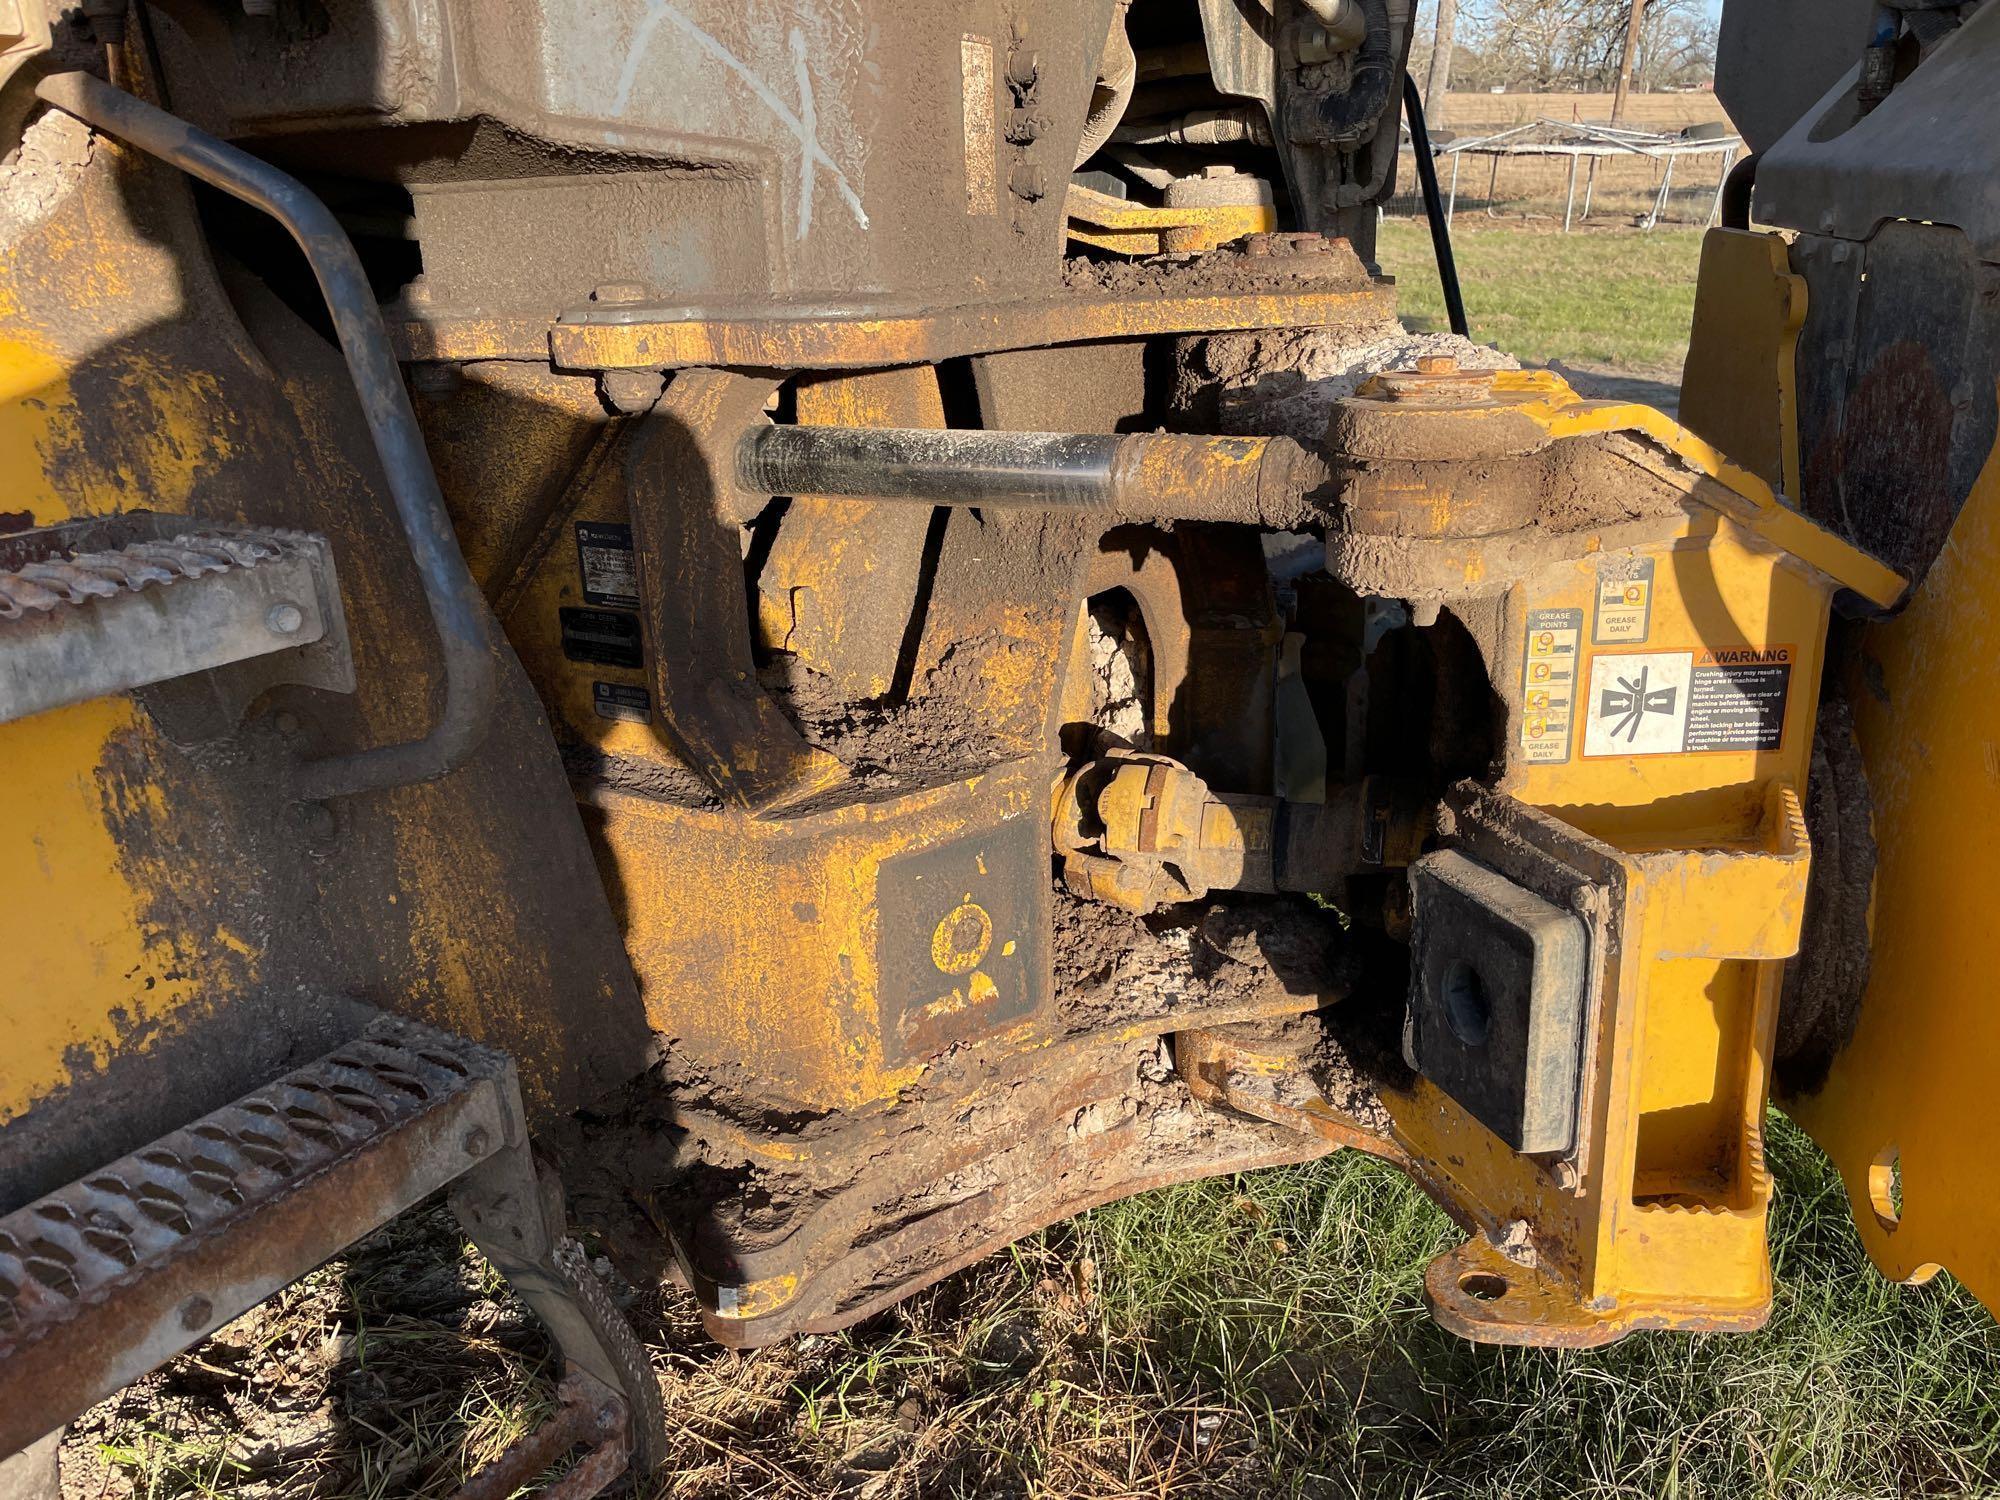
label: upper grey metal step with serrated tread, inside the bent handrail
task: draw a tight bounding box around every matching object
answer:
[0,512,354,724]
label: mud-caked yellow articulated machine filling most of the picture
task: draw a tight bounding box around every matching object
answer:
[0,0,2000,1496]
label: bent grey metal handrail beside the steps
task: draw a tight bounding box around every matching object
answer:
[36,72,498,802]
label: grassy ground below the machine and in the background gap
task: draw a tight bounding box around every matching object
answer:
[68,223,2000,1500]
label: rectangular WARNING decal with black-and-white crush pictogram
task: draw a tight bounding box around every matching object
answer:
[1584,646,1796,756]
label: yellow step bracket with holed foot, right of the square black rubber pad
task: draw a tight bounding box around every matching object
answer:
[1386,782,1808,1348]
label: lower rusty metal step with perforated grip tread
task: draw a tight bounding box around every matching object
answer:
[0,1018,524,1454]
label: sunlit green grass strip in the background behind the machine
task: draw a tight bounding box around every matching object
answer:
[1376,214,1702,380]
